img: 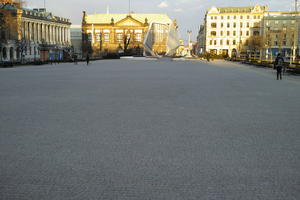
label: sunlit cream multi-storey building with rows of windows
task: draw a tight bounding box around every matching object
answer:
[198,5,268,56]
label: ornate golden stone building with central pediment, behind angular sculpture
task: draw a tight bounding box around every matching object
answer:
[82,12,177,56]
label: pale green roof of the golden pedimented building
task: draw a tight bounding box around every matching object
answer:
[85,13,172,24]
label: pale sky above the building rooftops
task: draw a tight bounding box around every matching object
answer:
[26,0,294,41]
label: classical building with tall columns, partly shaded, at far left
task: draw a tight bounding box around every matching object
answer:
[0,2,71,63]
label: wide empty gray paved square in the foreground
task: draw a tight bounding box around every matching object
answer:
[0,60,300,200]
